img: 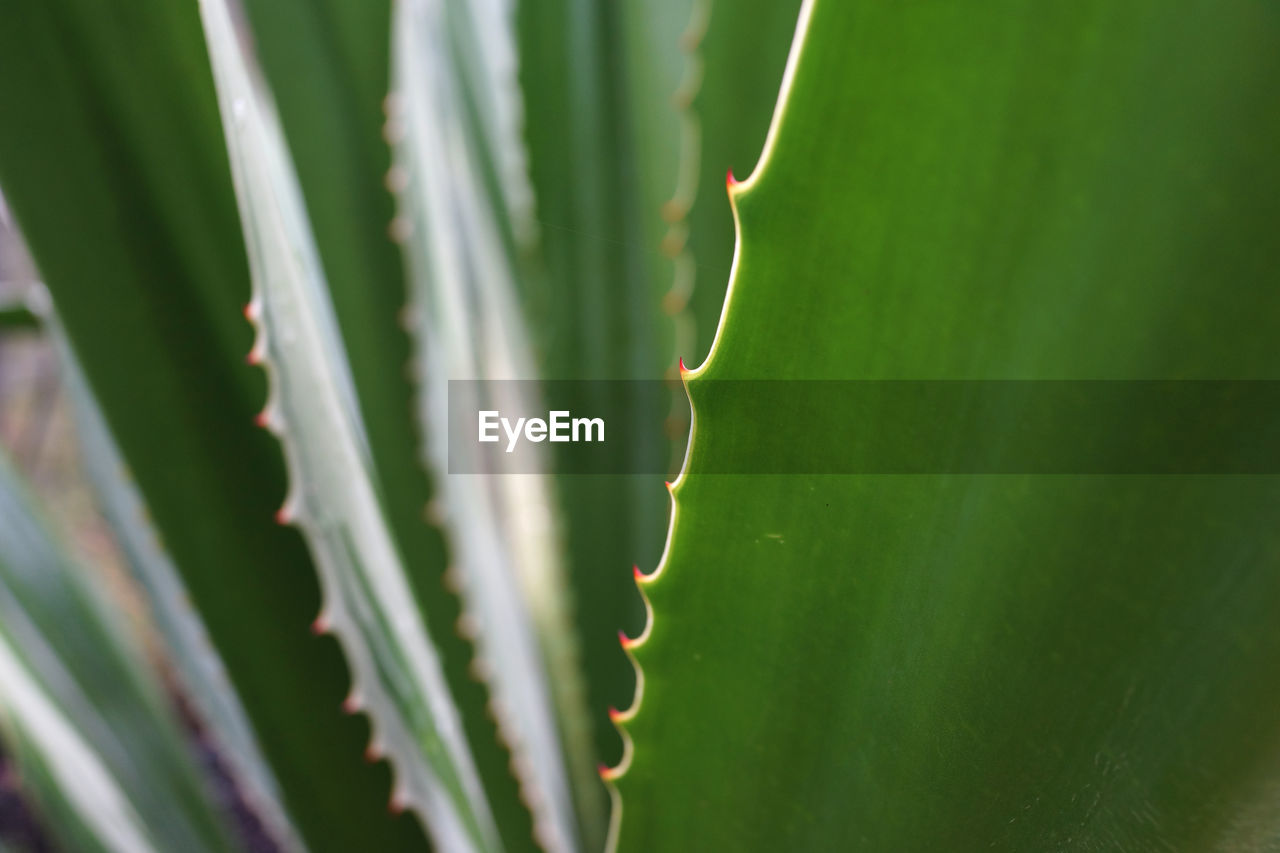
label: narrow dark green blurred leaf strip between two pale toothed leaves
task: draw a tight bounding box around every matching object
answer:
[227,0,531,848]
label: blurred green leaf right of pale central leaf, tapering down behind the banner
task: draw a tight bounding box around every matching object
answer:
[517,0,669,788]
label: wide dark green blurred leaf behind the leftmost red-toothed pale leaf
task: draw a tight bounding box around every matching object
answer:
[0,0,421,850]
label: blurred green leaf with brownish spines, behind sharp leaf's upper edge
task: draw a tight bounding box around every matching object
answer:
[622,0,800,368]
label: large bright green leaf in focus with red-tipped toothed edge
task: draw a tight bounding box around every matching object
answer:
[612,0,1280,850]
